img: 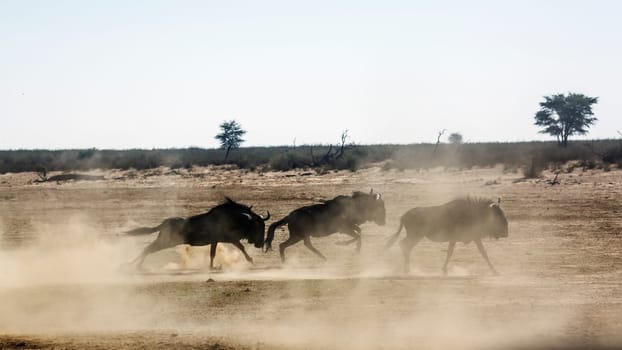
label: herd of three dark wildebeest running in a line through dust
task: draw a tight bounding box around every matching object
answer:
[126,190,508,274]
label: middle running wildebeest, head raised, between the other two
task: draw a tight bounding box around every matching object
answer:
[266,190,386,261]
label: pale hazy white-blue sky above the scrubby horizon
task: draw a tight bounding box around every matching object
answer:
[0,0,622,149]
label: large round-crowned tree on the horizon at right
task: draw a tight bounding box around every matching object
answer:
[534,93,598,147]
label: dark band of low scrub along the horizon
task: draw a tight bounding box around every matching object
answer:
[0,140,622,173]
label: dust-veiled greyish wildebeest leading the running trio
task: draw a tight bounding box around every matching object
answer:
[386,198,508,274]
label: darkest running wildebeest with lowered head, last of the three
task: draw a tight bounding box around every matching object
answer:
[126,197,270,269]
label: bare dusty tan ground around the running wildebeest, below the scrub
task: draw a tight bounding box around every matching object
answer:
[0,168,622,349]
